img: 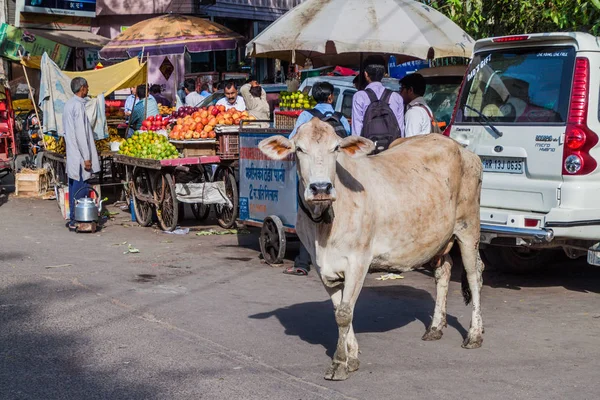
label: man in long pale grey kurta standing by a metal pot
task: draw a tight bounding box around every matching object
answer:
[63,77,100,229]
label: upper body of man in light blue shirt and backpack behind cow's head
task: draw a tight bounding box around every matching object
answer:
[290,82,350,139]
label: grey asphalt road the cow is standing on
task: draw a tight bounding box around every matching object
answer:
[0,197,600,400]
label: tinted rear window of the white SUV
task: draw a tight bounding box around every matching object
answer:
[456,47,575,124]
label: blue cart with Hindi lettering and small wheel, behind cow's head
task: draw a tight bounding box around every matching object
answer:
[239,127,298,265]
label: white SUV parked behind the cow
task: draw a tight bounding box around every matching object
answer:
[445,33,600,272]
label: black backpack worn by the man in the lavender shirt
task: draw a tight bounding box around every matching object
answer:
[361,89,401,154]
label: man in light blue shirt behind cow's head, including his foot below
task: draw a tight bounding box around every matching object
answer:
[283,82,351,275]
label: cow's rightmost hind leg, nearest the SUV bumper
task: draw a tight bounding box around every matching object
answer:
[457,236,484,349]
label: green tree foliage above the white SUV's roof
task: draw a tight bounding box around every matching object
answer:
[421,0,600,39]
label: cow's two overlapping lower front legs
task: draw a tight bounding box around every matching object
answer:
[325,264,367,381]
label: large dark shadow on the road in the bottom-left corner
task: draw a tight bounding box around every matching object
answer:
[0,284,164,400]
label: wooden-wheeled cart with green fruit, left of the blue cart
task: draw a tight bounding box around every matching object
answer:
[115,127,238,231]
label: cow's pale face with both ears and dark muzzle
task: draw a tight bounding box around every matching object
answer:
[258,118,374,204]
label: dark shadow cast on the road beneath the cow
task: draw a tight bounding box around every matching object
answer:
[249,285,467,357]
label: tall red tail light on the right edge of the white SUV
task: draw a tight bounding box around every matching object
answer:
[563,57,598,175]
